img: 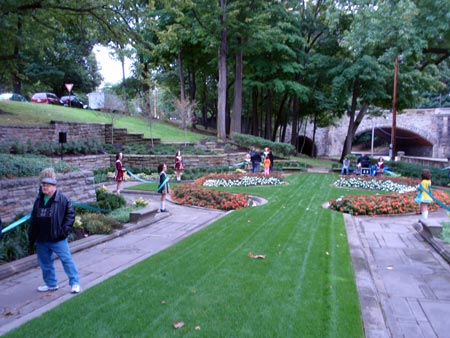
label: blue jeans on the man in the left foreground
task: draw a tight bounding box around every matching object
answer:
[36,239,80,287]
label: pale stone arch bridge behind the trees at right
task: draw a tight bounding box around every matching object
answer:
[296,108,450,158]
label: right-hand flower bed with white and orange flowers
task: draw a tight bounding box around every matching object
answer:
[329,178,450,216]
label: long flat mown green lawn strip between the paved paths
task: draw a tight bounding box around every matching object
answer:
[6,174,364,338]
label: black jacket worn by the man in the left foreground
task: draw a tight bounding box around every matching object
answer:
[28,190,75,243]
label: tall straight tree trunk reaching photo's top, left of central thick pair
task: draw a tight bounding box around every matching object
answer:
[217,0,227,140]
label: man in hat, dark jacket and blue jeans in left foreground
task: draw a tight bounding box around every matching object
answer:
[28,168,81,293]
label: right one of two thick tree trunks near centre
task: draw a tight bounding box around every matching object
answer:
[230,37,243,138]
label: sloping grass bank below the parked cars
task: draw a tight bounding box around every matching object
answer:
[0,101,205,142]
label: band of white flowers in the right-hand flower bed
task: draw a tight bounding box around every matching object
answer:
[334,177,416,194]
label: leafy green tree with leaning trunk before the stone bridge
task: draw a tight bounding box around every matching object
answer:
[331,1,449,159]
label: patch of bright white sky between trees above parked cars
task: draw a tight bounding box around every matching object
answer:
[94,45,132,87]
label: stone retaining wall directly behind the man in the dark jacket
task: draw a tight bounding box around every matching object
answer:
[0,170,96,222]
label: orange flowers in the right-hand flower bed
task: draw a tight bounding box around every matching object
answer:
[329,190,450,216]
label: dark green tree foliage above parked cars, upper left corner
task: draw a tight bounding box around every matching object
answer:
[0,0,142,94]
